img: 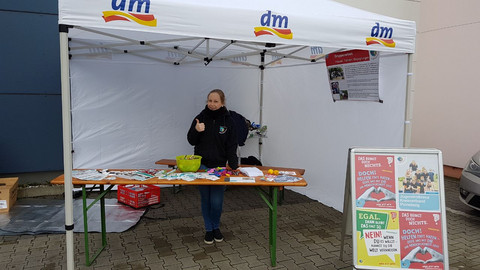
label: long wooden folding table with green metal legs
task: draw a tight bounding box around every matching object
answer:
[51,168,307,266]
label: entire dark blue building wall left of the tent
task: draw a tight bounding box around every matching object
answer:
[0,0,63,173]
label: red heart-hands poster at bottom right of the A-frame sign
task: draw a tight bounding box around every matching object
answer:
[399,211,444,270]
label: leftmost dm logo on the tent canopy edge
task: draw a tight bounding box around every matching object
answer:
[102,0,157,27]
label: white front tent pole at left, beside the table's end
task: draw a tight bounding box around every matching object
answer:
[60,29,75,269]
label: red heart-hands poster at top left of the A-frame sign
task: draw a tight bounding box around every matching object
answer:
[355,155,397,209]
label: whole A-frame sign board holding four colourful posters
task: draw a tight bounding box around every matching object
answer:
[341,148,448,269]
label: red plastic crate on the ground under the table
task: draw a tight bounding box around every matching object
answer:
[117,185,160,208]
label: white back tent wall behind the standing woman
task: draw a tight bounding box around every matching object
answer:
[70,59,260,169]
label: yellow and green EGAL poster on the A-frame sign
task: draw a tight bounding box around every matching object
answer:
[356,210,400,268]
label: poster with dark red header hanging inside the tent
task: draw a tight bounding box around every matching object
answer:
[325,50,380,101]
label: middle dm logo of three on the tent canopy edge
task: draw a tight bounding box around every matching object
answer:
[253,10,293,39]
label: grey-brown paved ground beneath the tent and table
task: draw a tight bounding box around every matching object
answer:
[0,178,480,270]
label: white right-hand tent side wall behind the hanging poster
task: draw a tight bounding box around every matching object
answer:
[262,54,408,211]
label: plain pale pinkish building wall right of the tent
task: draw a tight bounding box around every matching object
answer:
[412,0,480,168]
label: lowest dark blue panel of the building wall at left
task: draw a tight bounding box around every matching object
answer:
[0,95,63,173]
